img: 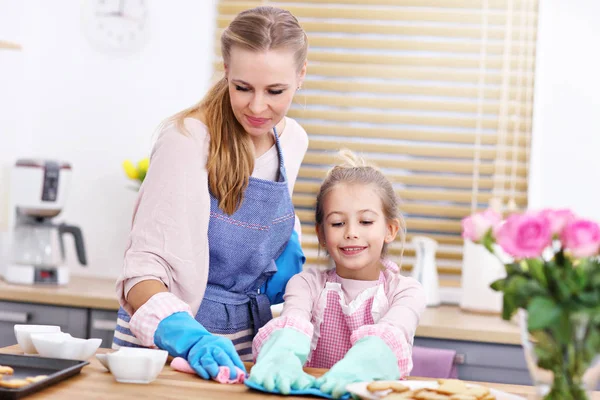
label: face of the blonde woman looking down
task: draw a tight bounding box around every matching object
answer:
[225,47,306,137]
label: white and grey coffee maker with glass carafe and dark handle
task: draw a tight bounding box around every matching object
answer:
[4,159,87,285]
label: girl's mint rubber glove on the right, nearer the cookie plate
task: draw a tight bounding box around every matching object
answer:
[316,336,400,398]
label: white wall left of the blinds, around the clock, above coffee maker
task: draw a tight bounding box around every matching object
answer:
[0,0,216,277]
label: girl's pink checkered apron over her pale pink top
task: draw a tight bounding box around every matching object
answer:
[305,273,385,368]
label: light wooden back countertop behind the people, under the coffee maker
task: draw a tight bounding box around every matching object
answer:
[0,276,521,345]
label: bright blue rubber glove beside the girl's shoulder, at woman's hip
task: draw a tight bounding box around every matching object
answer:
[260,231,306,304]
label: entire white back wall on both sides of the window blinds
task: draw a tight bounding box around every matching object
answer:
[0,0,600,277]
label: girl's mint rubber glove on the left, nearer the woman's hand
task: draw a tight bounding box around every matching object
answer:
[248,328,315,394]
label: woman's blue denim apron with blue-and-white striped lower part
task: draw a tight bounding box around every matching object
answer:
[113,127,295,359]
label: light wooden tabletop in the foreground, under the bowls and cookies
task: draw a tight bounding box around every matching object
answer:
[0,345,600,400]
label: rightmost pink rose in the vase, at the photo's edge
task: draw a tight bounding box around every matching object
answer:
[560,219,600,258]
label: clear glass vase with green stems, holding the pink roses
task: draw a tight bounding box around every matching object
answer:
[519,310,600,400]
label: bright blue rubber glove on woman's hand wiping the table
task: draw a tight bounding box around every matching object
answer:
[154,312,246,379]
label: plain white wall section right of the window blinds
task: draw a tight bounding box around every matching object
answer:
[529,0,600,221]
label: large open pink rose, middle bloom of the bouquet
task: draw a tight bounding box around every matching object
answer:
[495,213,552,258]
